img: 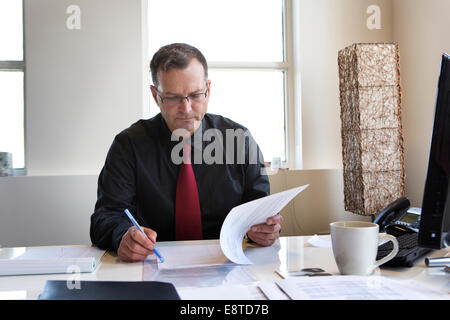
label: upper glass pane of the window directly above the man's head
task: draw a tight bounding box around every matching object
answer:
[148,0,283,62]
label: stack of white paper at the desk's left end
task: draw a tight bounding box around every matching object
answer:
[0,246,105,276]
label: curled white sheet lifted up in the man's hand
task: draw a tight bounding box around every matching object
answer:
[220,184,309,264]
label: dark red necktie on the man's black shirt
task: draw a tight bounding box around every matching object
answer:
[175,144,202,240]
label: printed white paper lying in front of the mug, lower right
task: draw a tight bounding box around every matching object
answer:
[276,276,450,300]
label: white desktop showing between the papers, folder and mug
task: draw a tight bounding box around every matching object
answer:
[0,235,450,300]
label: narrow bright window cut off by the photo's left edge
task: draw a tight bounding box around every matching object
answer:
[0,0,25,169]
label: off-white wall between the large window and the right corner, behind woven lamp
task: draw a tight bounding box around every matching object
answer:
[300,0,393,169]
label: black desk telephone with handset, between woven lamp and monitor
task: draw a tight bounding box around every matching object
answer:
[373,197,421,236]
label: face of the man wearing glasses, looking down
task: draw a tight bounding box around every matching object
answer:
[151,59,211,135]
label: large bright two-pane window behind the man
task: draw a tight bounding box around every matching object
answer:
[146,0,293,162]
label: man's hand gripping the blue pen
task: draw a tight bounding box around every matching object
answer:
[117,226,156,262]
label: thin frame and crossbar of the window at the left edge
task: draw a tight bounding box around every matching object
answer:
[0,0,27,176]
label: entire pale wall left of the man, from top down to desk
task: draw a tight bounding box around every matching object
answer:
[0,0,149,246]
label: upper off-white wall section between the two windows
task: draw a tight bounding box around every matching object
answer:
[24,0,148,176]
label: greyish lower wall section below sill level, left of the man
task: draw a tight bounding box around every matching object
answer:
[0,175,97,247]
